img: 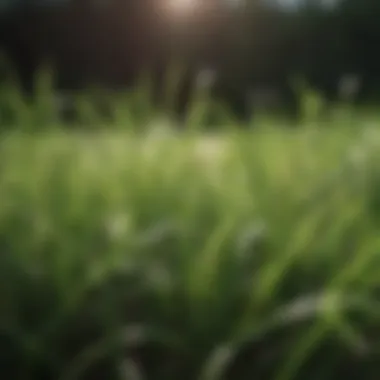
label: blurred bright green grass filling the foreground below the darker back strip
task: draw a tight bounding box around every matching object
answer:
[0,119,380,380]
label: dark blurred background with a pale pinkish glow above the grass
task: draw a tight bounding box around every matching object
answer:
[0,0,380,122]
